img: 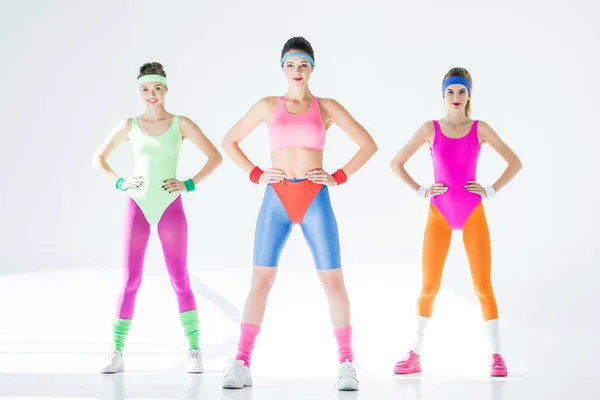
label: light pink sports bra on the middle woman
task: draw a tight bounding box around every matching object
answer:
[269,96,325,150]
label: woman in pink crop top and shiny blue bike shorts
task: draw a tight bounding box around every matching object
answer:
[222,37,377,390]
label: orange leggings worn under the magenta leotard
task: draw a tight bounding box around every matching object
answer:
[417,203,498,321]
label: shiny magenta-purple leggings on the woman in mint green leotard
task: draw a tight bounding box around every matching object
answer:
[117,196,196,319]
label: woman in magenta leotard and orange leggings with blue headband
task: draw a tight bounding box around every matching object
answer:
[392,68,521,376]
